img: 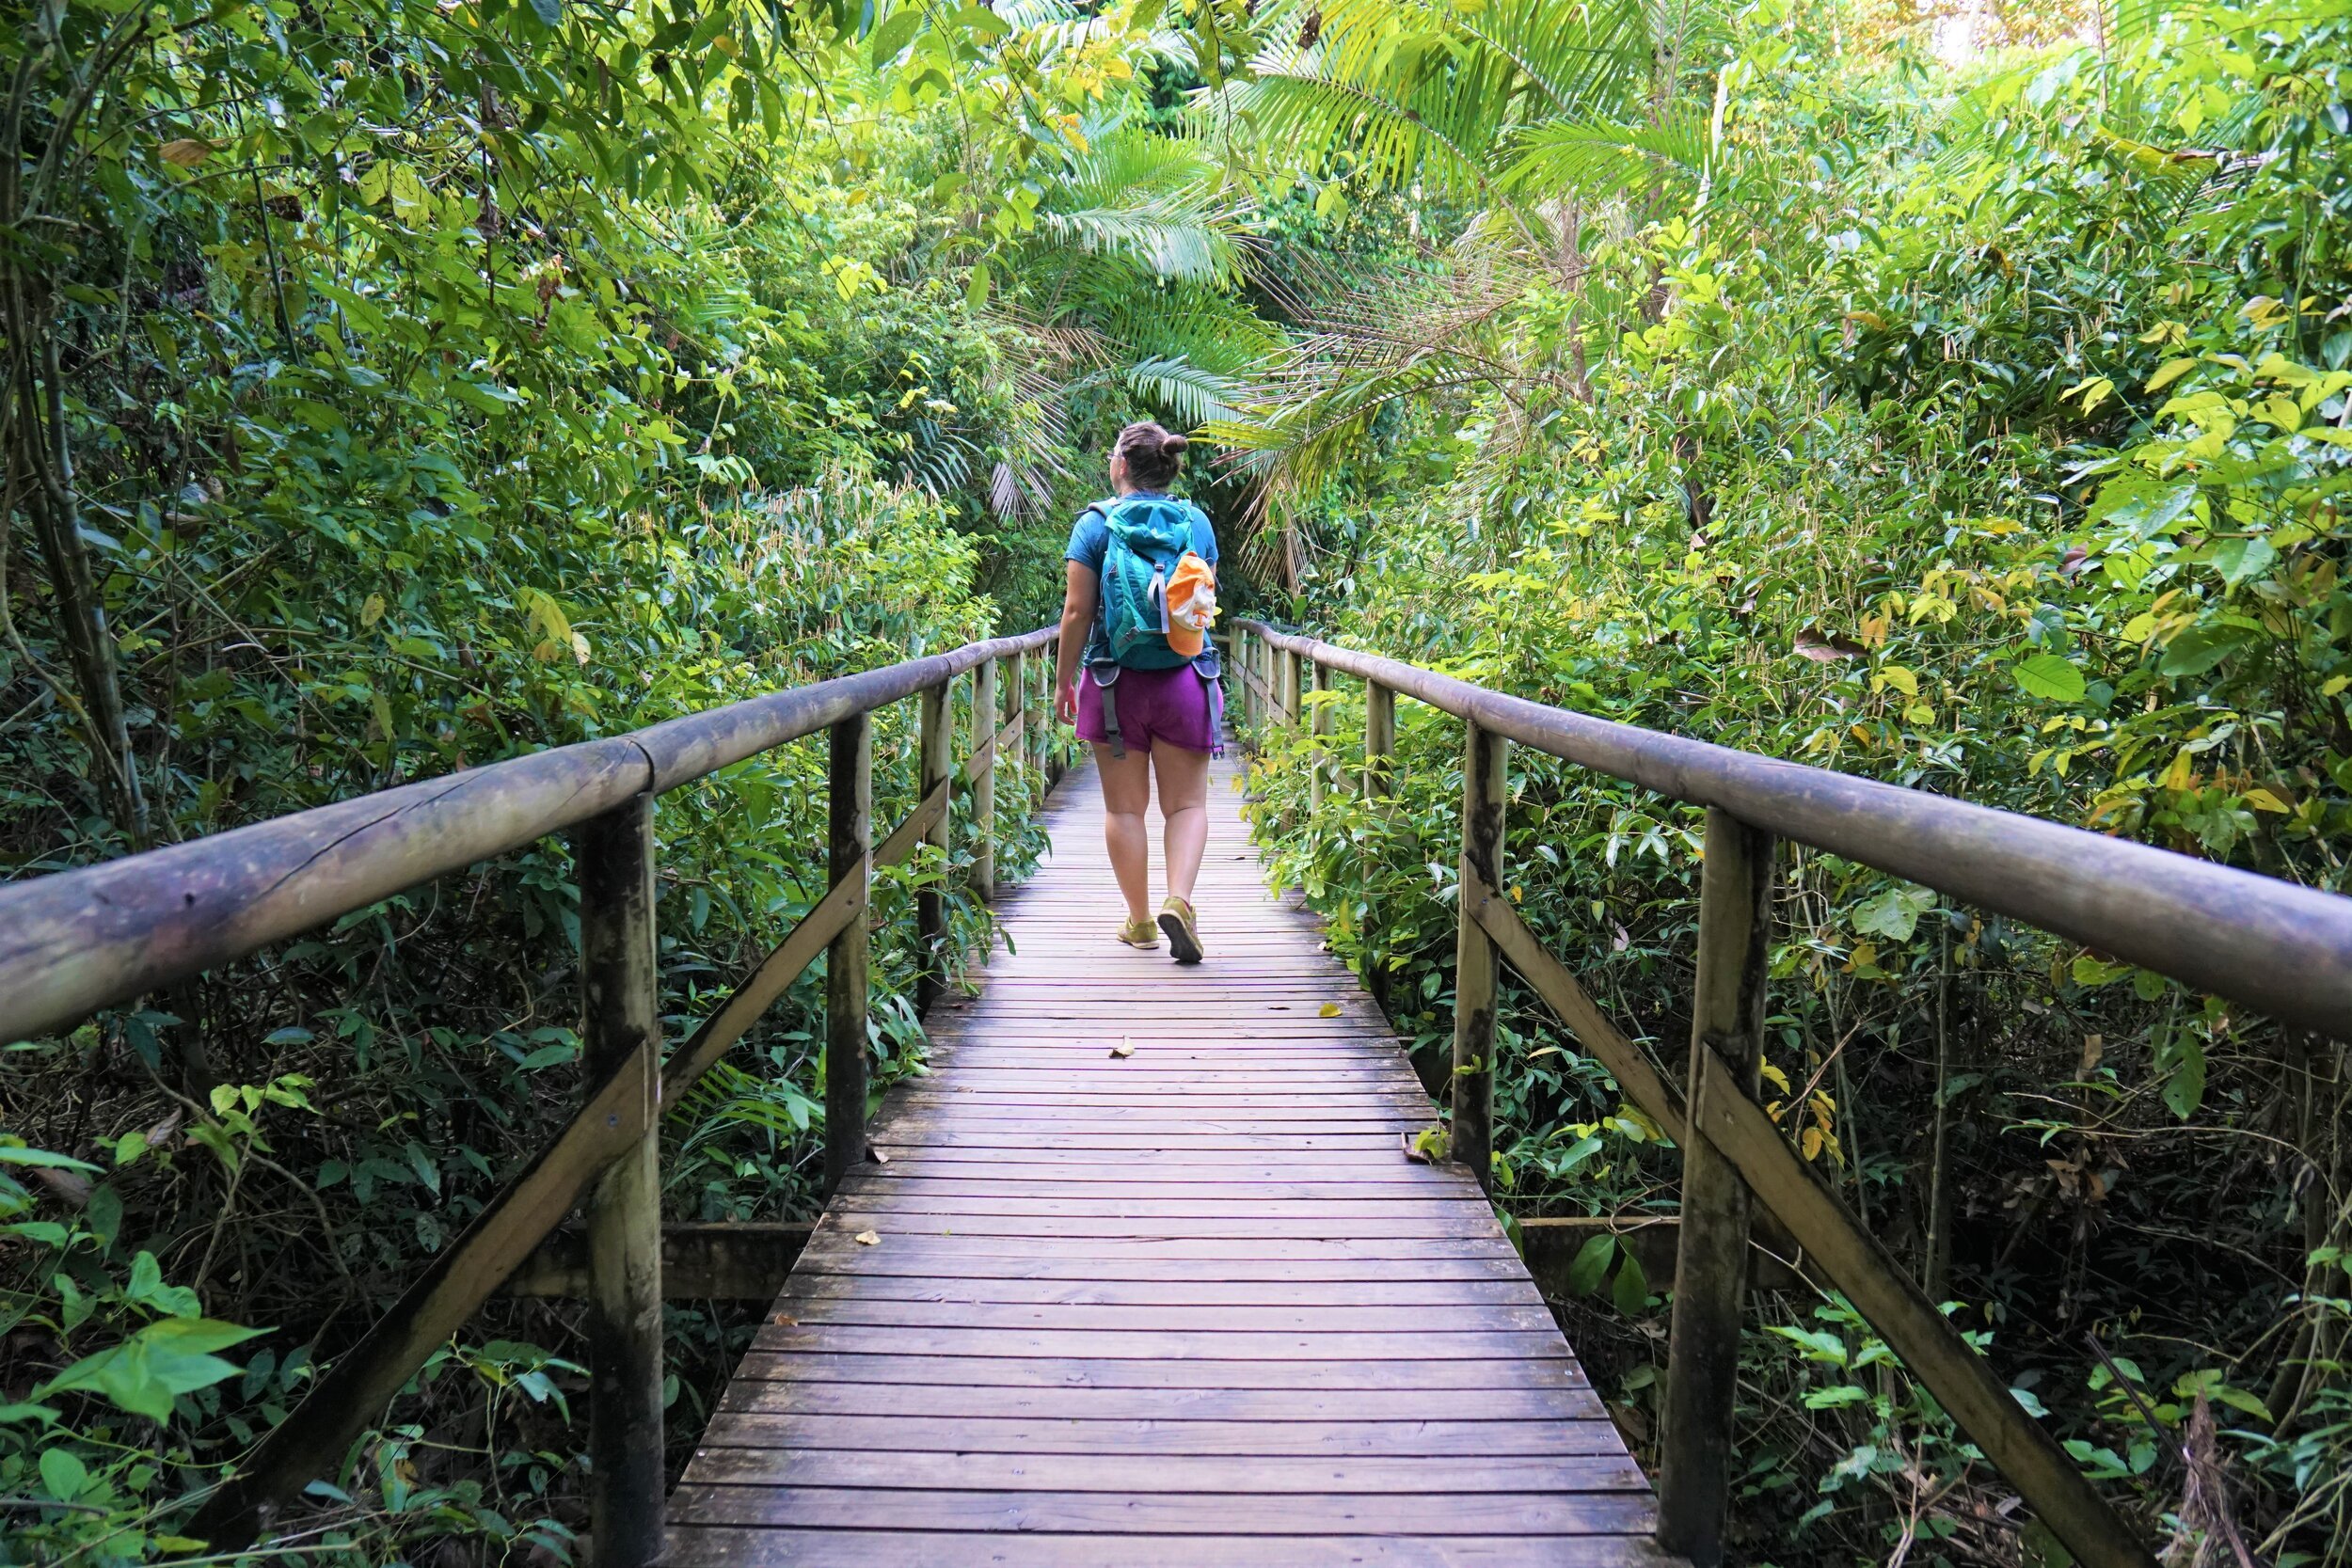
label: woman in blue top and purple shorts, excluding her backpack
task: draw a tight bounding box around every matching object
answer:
[1054,420,1221,964]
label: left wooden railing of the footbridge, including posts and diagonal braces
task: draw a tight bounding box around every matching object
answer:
[0,627,1063,1568]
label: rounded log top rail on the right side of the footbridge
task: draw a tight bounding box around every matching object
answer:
[1240,621,2352,1035]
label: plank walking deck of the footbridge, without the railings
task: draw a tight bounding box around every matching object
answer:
[666,762,1668,1568]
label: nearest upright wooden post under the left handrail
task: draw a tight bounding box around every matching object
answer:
[579,795,663,1568]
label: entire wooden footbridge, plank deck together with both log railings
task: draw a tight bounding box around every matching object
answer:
[0,621,2352,1568]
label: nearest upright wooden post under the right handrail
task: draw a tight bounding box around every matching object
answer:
[1659,806,1773,1568]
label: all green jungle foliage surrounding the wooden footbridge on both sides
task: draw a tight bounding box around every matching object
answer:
[0,0,2352,1566]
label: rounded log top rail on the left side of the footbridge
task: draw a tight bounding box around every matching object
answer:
[0,626,1058,1041]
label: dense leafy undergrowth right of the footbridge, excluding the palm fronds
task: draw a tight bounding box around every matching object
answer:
[1242,5,2352,1563]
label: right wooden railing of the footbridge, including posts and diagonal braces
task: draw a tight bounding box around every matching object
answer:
[1231,621,2352,1568]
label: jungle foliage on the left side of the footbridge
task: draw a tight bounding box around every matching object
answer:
[0,0,1278,1563]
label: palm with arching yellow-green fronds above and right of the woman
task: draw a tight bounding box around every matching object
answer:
[1204,0,1726,540]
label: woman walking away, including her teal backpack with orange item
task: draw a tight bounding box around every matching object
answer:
[1054,420,1223,964]
